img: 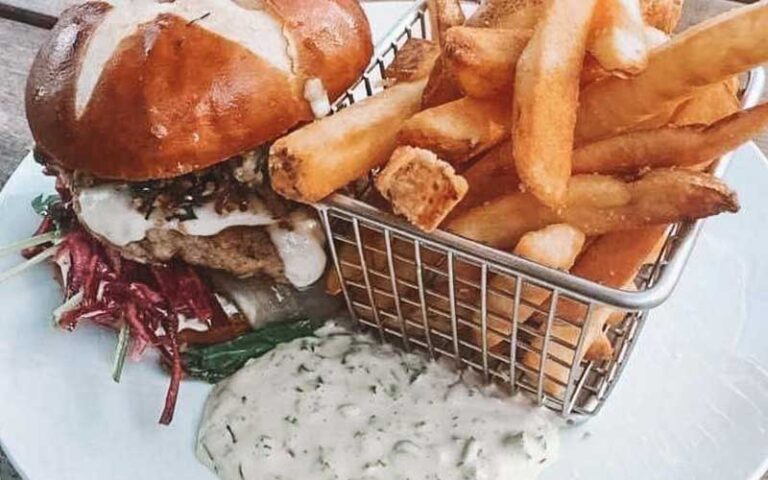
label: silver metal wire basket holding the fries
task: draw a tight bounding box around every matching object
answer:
[315,1,764,416]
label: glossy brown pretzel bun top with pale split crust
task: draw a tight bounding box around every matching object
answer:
[26,0,373,181]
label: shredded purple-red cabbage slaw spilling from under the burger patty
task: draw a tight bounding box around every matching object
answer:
[30,212,232,425]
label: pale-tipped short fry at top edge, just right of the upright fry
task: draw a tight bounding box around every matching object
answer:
[587,0,650,75]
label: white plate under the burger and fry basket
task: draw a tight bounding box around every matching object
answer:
[0,3,768,480]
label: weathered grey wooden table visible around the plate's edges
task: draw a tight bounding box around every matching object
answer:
[0,0,768,480]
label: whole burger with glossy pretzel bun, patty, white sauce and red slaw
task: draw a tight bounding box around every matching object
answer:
[26,0,372,423]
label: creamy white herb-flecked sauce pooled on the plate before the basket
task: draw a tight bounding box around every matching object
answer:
[197,326,558,480]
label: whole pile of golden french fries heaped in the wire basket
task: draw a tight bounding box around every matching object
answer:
[270,0,768,394]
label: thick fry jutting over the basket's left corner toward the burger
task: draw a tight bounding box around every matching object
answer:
[269,80,425,203]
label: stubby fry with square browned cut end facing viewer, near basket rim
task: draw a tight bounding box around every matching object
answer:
[376,147,467,232]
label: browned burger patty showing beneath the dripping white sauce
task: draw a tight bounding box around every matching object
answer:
[118,227,286,282]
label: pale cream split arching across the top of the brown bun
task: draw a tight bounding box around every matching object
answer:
[75,0,293,117]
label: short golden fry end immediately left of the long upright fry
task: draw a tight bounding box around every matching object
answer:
[443,27,533,98]
